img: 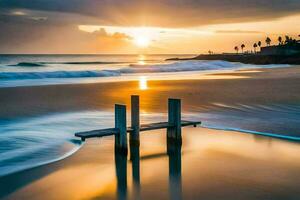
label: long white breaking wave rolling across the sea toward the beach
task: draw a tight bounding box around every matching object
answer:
[0,61,288,80]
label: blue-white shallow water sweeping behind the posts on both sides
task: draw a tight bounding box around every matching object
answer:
[0,104,300,176]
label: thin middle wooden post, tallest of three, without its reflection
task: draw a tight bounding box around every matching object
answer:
[130,95,140,146]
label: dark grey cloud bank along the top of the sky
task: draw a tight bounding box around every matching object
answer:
[0,0,300,27]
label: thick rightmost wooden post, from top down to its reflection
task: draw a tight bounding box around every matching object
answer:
[167,99,181,140]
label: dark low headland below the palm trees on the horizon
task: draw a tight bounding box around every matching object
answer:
[167,54,300,65]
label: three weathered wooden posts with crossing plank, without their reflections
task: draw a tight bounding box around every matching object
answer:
[75,95,201,152]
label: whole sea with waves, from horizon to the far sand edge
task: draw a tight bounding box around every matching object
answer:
[0,55,288,87]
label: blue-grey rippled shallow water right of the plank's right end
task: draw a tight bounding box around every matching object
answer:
[195,104,300,140]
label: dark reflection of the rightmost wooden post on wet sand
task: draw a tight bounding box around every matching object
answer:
[167,140,182,200]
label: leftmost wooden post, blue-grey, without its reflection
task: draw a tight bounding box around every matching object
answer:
[115,104,127,153]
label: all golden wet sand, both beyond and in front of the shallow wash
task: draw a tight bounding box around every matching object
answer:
[0,66,300,200]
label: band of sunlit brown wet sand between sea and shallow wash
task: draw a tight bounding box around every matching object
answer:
[0,67,300,119]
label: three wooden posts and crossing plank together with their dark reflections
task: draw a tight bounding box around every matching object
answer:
[75,95,201,200]
